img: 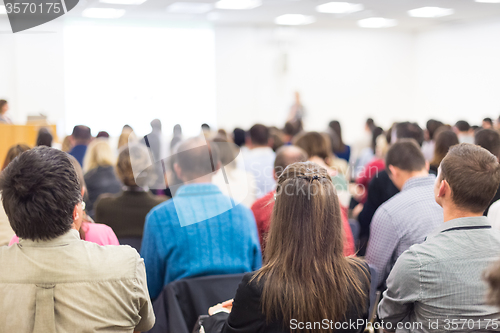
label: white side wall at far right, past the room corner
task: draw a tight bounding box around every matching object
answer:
[415,21,500,125]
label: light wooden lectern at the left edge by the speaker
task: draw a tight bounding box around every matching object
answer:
[0,124,57,169]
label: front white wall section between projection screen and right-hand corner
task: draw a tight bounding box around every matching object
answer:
[215,28,414,140]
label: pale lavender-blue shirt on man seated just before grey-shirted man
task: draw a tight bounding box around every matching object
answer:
[366,175,443,289]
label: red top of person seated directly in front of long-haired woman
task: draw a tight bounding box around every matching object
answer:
[252,191,355,256]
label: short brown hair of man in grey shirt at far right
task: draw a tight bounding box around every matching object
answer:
[439,143,500,213]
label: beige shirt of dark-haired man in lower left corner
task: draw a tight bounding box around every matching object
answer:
[0,229,155,333]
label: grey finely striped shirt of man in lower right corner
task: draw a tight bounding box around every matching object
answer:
[378,216,500,332]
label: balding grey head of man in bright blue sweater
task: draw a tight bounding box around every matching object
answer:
[174,137,220,182]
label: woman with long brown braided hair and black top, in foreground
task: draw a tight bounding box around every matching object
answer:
[209,162,370,333]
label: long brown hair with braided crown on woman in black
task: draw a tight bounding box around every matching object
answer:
[255,162,367,332]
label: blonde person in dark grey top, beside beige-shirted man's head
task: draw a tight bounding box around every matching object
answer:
[83,138,122,217]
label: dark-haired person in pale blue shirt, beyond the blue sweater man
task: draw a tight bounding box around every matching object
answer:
[243,124,276,199]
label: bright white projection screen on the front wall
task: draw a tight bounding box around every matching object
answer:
[64,22,216,136]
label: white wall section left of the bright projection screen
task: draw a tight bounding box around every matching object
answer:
[0,21,65,135]
